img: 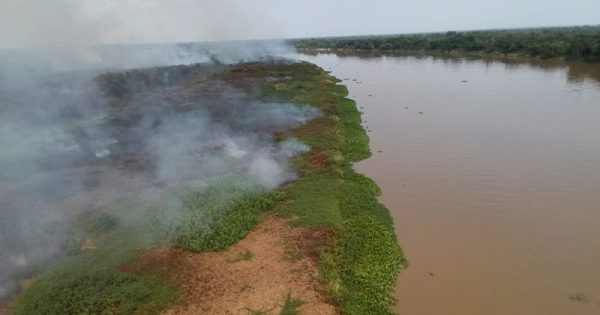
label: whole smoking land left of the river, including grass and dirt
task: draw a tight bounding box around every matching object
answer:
[0,58,403,314]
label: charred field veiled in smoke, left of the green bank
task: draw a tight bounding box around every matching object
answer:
[0,57,321,295]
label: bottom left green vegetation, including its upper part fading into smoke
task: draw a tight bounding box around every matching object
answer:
[13,232,179,315]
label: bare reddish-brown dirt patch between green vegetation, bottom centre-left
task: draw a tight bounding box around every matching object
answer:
[129,215,337,314]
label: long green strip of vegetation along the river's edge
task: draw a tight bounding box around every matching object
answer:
[263,64,405,314]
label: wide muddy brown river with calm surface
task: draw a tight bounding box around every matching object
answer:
[299,54,600,315]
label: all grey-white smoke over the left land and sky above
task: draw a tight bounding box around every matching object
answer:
[0,0,302,300]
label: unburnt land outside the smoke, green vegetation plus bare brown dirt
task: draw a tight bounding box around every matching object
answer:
[9,61,405,314]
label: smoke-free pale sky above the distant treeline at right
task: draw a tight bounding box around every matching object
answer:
[264,0,600,37]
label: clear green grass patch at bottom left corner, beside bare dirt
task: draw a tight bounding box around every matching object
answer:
[15,265,178,314]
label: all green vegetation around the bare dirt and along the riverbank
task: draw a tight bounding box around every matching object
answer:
[14,63,405,314]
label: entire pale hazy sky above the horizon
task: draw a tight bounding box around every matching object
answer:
[0,0,600,47]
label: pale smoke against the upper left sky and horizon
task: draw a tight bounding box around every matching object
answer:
[0,0,291,78]
